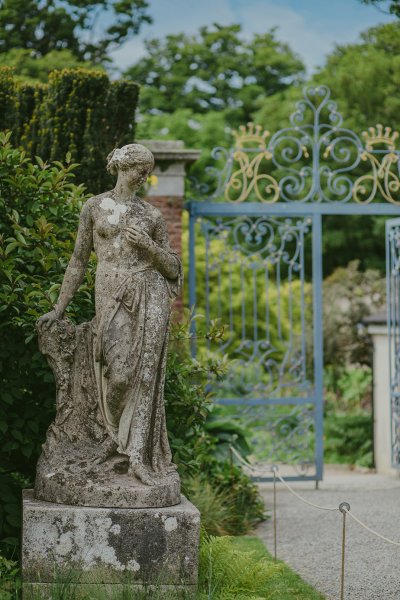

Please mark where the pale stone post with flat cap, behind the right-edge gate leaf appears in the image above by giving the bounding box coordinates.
[364,312,399,477]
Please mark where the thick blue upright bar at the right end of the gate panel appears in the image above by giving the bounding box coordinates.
[312,214,324,481]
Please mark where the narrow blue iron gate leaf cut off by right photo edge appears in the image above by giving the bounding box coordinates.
[386,218,400,469]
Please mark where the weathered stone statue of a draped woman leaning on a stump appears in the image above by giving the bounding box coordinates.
[35,144,182,507]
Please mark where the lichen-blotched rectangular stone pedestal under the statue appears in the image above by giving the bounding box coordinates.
[22,490,200,598]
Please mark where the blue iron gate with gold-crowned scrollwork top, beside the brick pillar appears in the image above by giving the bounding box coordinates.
[188,86,400,480]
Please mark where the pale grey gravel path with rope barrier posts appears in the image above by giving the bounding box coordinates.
[257,468,400,600]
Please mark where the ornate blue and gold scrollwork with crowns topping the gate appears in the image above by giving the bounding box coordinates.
[208,86,400,204]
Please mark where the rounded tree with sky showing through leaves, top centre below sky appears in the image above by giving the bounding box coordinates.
[125,24,304,123]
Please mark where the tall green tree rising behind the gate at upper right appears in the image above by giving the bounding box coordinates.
[253,21,400,274]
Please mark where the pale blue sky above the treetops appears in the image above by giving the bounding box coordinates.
[108,0,395,73]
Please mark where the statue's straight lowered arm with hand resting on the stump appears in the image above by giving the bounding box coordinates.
[38,202,93,325]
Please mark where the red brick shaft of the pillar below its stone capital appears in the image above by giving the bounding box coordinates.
[146,196,183,315]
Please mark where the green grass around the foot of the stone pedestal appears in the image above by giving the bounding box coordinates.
[0,536,324,600]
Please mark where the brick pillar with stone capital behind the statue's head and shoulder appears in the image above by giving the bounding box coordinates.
[138,140,200,314]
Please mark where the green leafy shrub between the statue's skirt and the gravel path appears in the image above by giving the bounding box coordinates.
[165,320,265,535]
